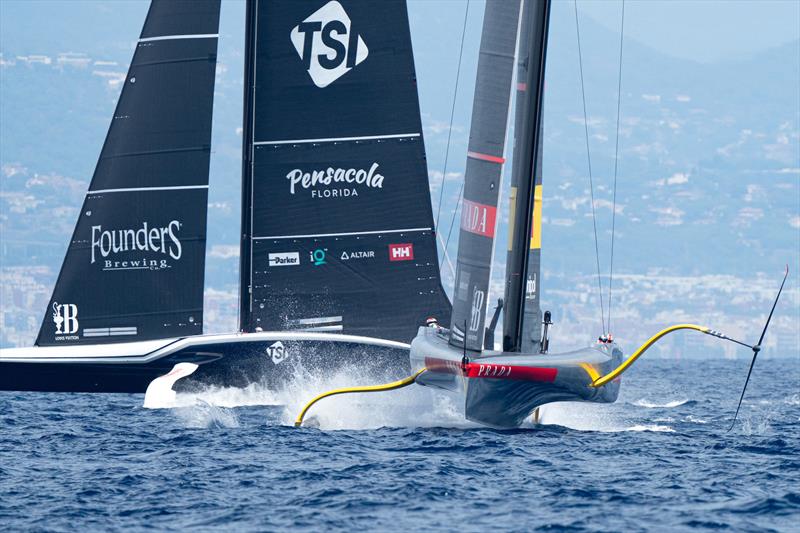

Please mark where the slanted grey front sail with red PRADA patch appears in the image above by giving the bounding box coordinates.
[450,0,520,350]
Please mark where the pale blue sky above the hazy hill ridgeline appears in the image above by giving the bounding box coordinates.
[0,0,800,62]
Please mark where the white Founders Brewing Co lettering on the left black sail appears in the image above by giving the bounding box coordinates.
[91,220,183,270]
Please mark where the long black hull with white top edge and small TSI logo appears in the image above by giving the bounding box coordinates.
[0,336,410,393]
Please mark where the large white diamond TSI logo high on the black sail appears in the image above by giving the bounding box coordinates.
[289,0,369,89]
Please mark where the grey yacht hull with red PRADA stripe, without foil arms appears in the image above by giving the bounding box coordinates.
[410,328,622,428]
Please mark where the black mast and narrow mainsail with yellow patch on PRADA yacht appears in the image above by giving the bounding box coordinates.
[503,0,550,352]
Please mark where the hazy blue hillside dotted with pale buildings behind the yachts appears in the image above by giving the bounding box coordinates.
[0,2,800,354]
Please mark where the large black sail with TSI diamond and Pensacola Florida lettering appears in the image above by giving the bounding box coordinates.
[241,0,450,342]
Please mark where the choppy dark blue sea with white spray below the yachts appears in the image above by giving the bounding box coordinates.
[0,358,800,531]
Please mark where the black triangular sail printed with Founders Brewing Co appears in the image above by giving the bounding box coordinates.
[36,0,220,346]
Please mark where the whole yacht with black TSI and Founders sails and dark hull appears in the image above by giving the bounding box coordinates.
[0,0,450,392]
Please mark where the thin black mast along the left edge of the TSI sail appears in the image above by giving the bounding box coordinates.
[239,0,256,331]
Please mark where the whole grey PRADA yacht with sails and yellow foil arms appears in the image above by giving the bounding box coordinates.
[400,0,789,428]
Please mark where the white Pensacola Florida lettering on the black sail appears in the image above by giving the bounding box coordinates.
[286,163,383,199]
